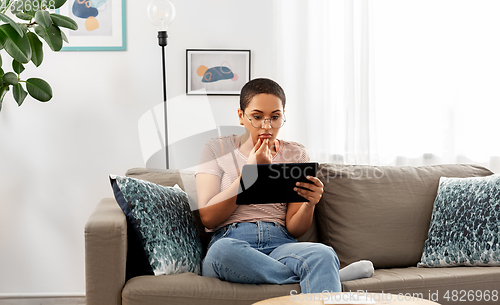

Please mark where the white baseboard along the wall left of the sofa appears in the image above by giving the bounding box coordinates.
[0,293,85,305]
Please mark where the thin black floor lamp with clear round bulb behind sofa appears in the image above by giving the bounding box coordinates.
[147,0,175,169]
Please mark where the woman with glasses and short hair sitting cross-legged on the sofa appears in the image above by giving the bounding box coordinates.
[195,78,372,293]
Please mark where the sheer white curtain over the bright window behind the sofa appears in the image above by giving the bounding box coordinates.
[277,0,500,172]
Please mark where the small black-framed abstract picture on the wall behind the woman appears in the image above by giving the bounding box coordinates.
[186,49,250,95]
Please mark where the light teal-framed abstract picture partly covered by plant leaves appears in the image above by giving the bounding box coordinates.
[56,0,127,51]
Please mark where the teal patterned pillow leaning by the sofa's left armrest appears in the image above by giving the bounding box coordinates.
[110,175,202,275]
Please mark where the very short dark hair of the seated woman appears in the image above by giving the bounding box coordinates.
[240,78,286,111]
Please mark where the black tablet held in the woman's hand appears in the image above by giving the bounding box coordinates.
[236,162,318,205]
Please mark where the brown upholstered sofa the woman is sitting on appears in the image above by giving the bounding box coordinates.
[85,163,500,305]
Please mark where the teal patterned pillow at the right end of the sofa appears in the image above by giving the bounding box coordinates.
[418,175,500,267]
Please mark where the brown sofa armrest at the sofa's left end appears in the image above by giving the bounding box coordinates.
[85,198,127,305]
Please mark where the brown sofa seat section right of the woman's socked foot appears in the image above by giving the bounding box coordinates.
[342,267,500,305]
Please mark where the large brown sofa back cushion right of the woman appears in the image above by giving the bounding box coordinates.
[316,163,492,269]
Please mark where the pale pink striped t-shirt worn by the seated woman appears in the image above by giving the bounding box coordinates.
[195,135,310,232]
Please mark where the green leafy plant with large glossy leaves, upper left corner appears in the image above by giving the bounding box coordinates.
[0,0,78,110]
